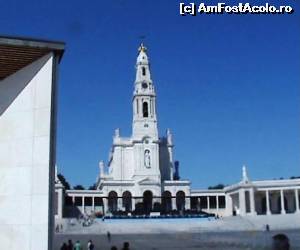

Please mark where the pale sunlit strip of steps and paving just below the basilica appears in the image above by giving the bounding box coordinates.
[57,214,300,235]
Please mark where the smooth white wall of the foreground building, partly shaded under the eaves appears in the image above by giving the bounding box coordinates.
[0,54,53,250]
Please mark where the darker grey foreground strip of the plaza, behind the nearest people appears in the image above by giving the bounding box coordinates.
[54,230,300,250]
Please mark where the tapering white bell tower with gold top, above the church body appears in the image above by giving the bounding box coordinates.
[132,44,158,140]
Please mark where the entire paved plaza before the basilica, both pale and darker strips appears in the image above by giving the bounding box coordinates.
[55,214,300,250]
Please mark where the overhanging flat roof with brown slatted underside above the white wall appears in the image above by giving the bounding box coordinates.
[0,35,65,80]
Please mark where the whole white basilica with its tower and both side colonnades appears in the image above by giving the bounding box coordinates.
[55,44,300,218]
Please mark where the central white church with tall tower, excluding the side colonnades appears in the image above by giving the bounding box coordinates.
[97,45,190,215]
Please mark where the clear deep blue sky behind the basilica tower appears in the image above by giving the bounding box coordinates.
[0,0,300,188]
